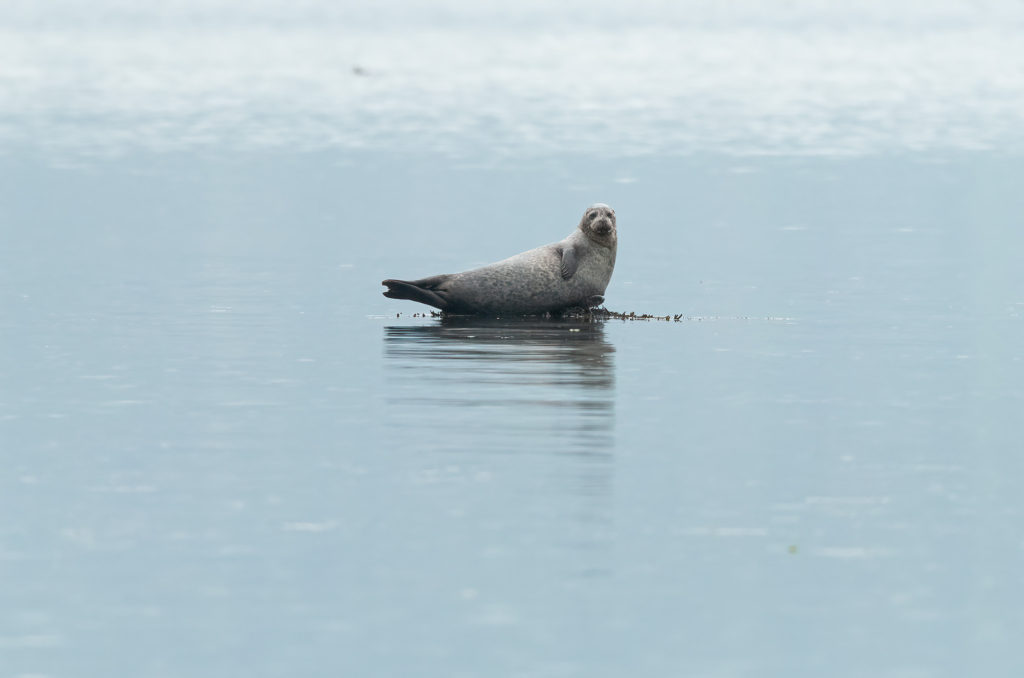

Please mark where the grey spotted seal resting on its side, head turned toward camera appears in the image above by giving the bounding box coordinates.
[381,203,618,314]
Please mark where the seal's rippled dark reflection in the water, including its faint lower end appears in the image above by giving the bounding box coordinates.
[381,315,616,540]
